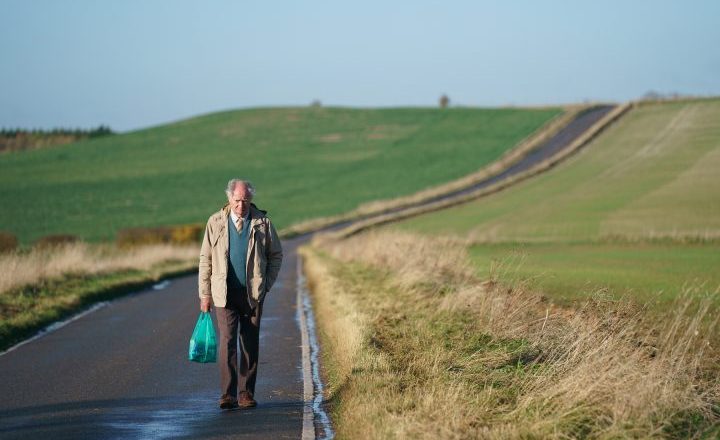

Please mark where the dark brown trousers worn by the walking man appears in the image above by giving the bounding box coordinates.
[215,290,262,397]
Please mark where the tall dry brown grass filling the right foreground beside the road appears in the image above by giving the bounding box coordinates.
[305,232,720,438]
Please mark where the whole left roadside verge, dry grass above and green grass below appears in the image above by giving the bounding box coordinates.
[0,243,197,351]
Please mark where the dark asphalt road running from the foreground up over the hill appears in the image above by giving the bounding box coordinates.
[0,107,610,439]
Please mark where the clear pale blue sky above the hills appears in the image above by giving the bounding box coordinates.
[0,0,720,131]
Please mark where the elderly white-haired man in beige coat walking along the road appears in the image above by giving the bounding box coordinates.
[199,179,283,409]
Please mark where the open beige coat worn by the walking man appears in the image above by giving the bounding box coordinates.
[198,204,282,308]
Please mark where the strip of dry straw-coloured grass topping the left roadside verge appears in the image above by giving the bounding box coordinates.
[0,242,198,293]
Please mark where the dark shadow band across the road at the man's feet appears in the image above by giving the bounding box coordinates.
[0,396,303,439]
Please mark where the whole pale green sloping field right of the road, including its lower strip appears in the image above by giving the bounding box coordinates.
[391,99,720,299]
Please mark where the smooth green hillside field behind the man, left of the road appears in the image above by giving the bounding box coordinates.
[0,108,561,243]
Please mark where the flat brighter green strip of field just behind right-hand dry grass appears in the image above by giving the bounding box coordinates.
[470,243,720,303]
